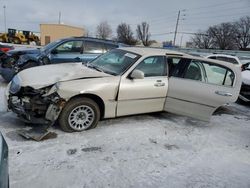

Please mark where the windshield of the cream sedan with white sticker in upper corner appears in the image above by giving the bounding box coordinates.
[87,49,141,75]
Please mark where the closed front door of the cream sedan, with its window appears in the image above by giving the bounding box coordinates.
[117,56,168,116]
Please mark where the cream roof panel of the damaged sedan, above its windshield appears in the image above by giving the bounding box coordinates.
[119,47,188,56]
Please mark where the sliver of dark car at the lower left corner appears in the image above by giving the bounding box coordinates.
[0,132,9,188]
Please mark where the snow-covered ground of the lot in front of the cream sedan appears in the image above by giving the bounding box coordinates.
[0,76,250,188]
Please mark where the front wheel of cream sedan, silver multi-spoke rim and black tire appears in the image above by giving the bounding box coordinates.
[58,97,100,132]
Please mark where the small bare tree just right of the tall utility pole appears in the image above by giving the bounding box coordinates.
[191,31,212,49]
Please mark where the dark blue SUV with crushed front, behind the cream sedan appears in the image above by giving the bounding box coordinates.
[0,37,125,82]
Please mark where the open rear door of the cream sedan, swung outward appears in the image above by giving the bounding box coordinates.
[164,58,241,121]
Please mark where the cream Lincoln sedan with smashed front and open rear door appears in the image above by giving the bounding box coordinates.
[7,47,241,132]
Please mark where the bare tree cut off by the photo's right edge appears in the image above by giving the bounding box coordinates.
[234,16,250,49]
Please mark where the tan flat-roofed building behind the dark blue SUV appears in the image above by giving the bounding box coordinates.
[40,24,86,46]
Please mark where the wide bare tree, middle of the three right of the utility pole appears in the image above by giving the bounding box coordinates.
[208,23,236,50]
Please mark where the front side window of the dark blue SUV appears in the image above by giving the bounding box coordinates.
[56,41,82,53]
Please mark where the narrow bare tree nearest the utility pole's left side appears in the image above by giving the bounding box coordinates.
[136,22,152,46]
